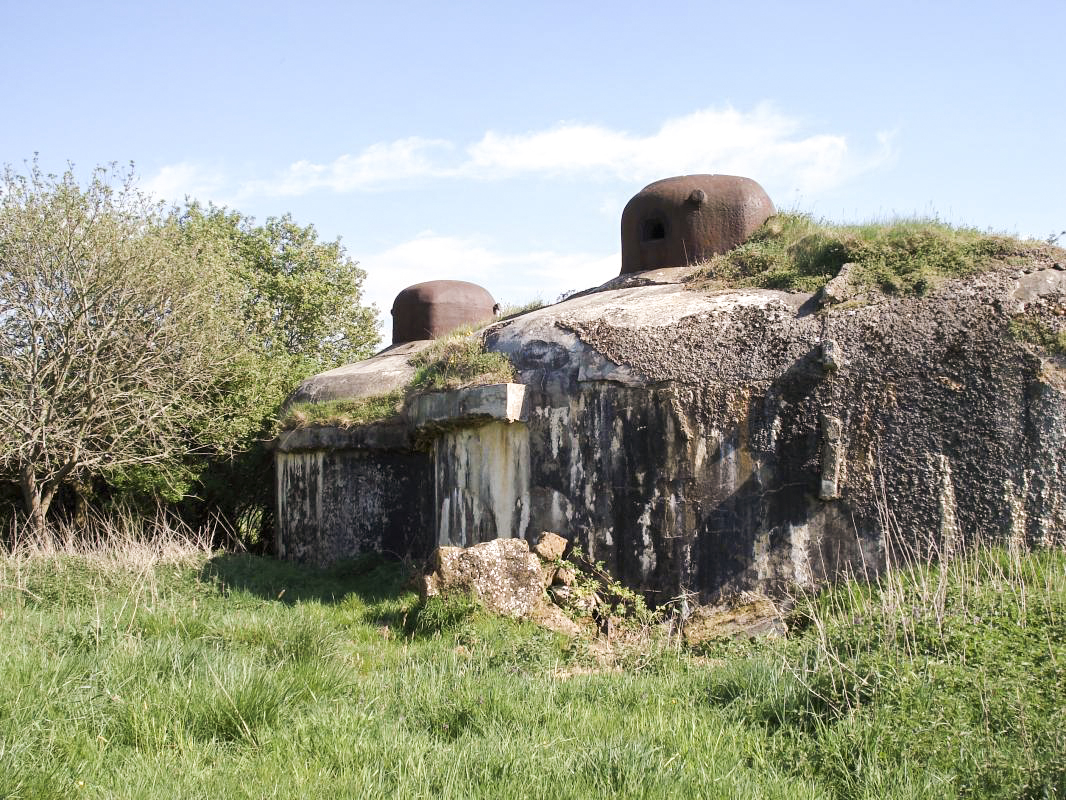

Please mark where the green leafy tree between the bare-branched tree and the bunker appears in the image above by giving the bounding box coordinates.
[162,202,379,538]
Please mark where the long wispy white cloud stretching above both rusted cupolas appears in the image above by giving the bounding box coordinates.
[141,105,892,198]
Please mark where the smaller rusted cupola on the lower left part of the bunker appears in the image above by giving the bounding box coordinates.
[392,281,496,345]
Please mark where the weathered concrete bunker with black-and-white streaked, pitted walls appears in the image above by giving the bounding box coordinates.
[276,176,1066,602]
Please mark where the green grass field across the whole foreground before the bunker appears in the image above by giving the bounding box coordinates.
[0,526,1066,800]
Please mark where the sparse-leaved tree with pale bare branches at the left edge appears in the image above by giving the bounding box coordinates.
[0,162,241,527]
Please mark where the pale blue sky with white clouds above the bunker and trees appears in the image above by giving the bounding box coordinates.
[0,0,1066,330]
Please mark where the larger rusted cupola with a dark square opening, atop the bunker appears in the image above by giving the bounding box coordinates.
[621,175,776,275]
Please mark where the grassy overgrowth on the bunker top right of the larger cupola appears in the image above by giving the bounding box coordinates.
[691,213,1066,294]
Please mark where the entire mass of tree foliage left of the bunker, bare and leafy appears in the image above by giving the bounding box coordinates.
[0,162,377,533]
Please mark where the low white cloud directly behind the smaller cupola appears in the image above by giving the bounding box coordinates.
[359,231,621,324]
